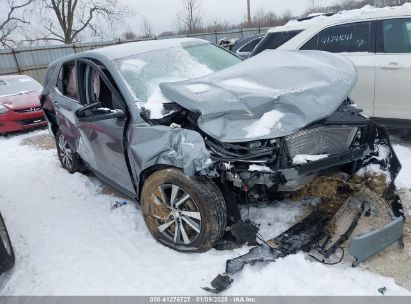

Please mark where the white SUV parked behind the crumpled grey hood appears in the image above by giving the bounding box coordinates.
[253,4,411,127]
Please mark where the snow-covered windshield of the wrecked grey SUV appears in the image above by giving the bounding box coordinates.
[116,43,241,102]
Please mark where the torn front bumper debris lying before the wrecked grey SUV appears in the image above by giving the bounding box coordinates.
[203,126,405,293]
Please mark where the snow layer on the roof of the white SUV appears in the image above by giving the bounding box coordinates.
[268,3,411,33]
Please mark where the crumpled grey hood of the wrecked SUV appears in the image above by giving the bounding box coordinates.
[160,50,357,142]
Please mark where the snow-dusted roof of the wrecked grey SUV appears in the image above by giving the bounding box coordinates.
[85,38,209,60]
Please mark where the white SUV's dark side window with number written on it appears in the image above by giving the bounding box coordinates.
[301,22,371,53]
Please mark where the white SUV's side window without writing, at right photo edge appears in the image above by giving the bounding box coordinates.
[377,18,411,53]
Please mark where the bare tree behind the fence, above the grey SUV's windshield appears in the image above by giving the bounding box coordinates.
[177,0,204,34]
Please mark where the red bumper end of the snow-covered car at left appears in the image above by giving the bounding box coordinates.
[0,110,47,133]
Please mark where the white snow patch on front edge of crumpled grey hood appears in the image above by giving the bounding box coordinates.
[244,110,284,138]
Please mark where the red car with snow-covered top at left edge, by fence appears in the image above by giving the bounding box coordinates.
[0,75,47,134]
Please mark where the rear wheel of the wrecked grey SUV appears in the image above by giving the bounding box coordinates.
[56,129,83,174]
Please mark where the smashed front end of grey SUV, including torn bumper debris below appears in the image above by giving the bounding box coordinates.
[205,100,405,293]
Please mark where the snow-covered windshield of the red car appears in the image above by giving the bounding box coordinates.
[0,76,42,97]
